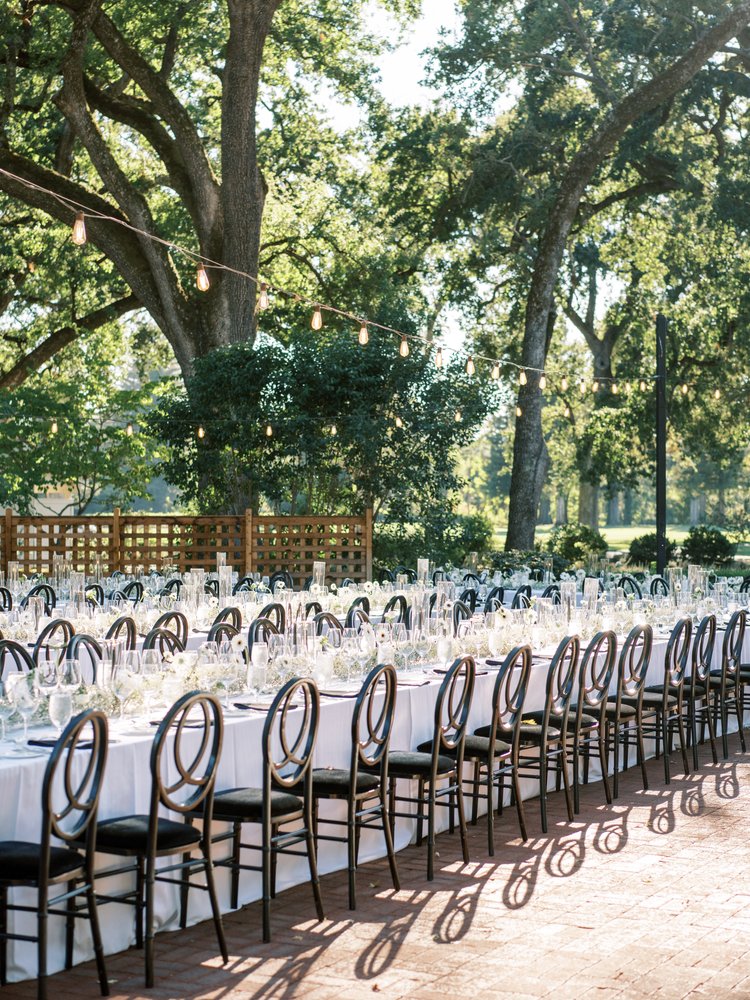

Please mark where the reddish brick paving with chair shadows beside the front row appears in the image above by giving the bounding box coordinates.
[5,737,750,1000]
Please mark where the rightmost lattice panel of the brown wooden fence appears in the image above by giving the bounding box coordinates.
[251,516,371,586]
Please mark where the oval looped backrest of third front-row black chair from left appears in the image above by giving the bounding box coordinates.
[263,677,320,796]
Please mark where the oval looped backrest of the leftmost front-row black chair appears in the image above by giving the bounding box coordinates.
[41,709,108,864]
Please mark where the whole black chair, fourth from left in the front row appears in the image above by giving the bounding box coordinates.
[313,664,401,910]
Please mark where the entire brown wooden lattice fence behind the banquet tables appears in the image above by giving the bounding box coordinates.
[0,508,372,584]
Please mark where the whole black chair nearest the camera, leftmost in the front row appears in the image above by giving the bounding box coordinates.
[0,711,109,1000]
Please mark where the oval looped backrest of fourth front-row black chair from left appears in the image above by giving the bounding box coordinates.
[351,663,398,772]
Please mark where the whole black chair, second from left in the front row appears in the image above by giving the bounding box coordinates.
[89,691,229,987]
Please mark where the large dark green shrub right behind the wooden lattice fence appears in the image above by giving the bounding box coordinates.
[151,328,500,523]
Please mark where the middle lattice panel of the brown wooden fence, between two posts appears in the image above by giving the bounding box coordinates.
[120,515,245,573]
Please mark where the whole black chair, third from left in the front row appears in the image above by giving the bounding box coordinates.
[207,677,325,941]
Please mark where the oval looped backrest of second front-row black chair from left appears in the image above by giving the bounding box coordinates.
[149,691,224,824]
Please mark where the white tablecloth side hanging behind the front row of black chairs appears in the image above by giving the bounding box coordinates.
[0,632,750,982]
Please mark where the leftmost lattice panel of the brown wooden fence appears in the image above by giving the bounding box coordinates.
[9,517,115,575]
